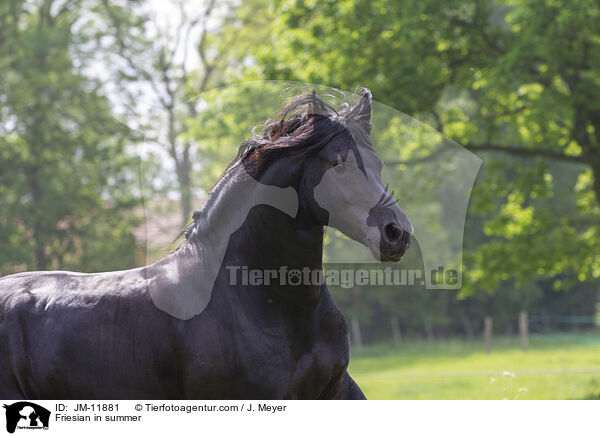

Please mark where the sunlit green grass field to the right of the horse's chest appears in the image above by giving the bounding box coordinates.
[350,333,600,400]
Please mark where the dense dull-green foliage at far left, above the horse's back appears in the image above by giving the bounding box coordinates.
[0,1,137,273]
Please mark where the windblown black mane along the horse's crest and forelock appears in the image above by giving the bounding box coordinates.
[184,88,371,240]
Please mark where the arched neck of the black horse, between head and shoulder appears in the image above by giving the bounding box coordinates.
[144,164,323,320]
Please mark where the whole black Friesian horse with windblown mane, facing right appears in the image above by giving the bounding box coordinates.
[0,90,413,399]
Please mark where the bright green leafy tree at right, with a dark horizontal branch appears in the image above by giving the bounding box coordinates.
[255,0,600,293]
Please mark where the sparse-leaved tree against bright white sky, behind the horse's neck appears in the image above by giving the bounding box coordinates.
[100,0,269,225]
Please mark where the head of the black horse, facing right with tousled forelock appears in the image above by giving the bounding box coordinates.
[234,89,414,262]
